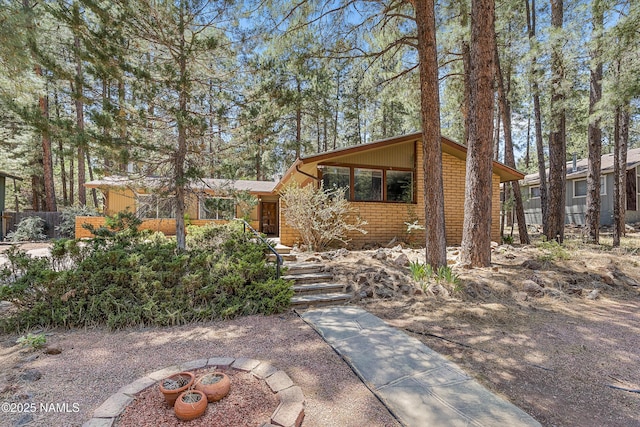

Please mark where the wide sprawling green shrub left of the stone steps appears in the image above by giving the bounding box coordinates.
[0,222,293,331]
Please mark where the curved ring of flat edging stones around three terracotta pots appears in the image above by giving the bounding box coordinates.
[82,357,305,427]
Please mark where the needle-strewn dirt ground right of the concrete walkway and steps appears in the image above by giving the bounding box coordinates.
[0,233,640,427]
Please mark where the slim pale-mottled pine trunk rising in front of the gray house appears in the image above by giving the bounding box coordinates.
[583,0,604,244]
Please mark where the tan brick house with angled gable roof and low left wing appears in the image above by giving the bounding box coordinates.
[76,133,524,247]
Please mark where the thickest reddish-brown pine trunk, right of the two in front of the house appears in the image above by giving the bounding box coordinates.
[460,0,495,267]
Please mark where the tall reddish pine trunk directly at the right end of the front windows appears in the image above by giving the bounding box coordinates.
[413,0,447,267]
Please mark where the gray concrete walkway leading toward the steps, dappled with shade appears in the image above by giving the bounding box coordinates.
[301,307,540,427]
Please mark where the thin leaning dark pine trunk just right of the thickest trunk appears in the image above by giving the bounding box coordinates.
[493,32,530,245]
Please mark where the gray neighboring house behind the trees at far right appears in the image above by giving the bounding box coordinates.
[521,148,640,225]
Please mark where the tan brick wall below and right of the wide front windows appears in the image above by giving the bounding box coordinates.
[280,142,500,248]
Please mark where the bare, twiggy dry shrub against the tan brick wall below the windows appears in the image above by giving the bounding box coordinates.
[280,185,367,251]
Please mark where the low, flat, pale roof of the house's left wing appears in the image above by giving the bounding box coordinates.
[85,176,277,194]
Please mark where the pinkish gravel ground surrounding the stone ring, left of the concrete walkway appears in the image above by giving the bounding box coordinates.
[0,313,399,427]
